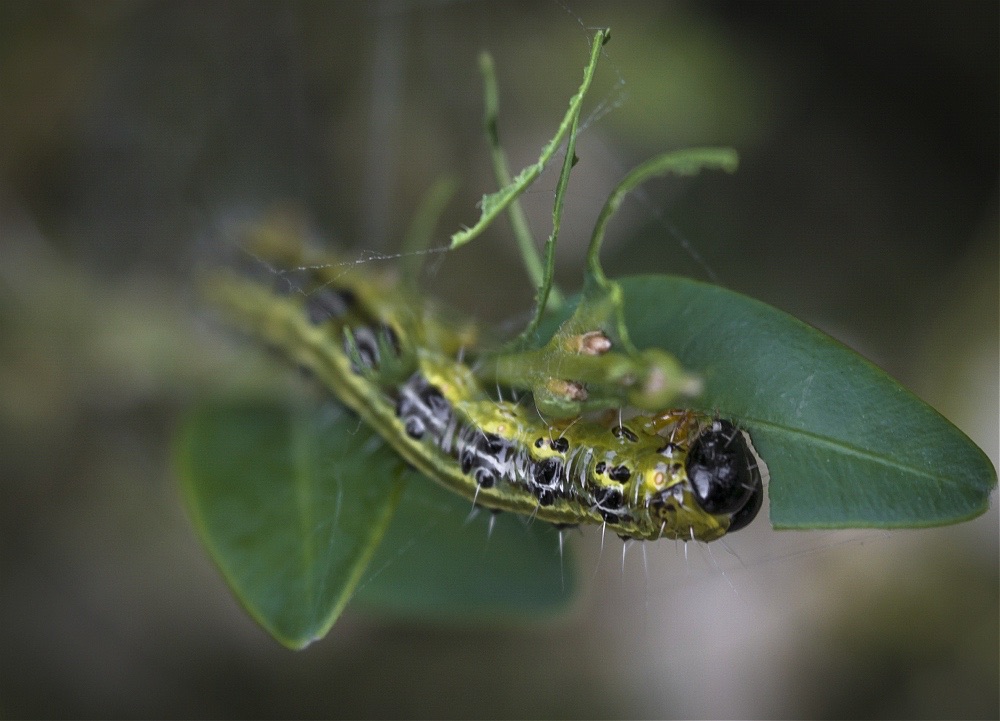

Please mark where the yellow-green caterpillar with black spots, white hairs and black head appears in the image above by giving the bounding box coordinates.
[204,222,763,541]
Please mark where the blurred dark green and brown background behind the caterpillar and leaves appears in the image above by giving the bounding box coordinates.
[0,0,1000,718]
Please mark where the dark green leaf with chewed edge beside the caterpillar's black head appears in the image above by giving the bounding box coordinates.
[592,276,997,528]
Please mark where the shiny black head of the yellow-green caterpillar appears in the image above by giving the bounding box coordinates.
[686,419,764,533]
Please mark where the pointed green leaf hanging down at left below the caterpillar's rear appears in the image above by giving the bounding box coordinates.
[178,403,404,648]
